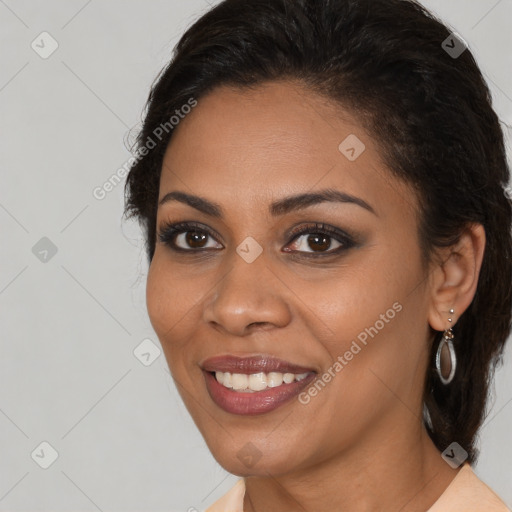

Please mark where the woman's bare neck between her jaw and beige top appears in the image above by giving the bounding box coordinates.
[244,418,459,512]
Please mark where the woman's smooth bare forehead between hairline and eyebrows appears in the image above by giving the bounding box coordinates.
[159,82,416,218]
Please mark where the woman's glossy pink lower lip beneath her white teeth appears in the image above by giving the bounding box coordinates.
[203,372,316,415]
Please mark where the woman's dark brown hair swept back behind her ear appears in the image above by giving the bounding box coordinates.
[125,0,512,462]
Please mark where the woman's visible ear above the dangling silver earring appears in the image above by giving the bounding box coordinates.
[429,224,485,331]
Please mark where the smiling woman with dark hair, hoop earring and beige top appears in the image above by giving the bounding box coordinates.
[126,0,512,512]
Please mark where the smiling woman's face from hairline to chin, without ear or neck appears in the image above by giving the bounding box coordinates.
[147,82,436,475]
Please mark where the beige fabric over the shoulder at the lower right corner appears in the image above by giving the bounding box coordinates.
[427,463,511,512]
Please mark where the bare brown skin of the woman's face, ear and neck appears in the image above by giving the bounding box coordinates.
[147,81,485,512]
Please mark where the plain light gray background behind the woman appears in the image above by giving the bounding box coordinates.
[0,0,512,512]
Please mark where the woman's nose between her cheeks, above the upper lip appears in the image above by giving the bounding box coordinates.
[203,252,291,336]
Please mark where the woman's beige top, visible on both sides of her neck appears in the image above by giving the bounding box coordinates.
[206,463,511,512]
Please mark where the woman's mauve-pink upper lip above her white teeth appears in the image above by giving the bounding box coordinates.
[201,355,315,375]
